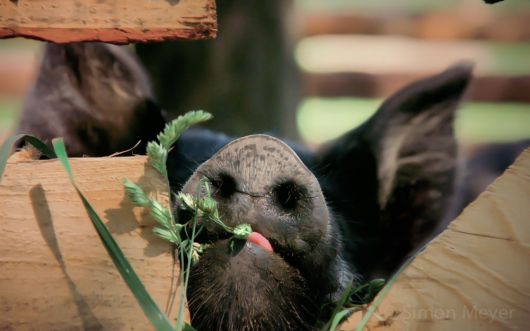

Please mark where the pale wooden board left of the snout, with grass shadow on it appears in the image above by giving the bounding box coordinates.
[0,153,185,330]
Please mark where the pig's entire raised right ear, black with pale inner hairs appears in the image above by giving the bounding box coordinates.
[314,64,471,274]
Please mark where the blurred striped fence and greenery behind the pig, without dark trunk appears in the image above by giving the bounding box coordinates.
[0,0,530,146]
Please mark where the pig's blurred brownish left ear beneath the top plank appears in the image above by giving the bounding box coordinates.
[18,43,164,156]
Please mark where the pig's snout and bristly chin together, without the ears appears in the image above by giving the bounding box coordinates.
[179,135,349,330]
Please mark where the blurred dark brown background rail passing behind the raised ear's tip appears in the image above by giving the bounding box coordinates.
[0,52,530,103]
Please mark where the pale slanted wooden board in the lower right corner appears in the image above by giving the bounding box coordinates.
[342,149,530,331]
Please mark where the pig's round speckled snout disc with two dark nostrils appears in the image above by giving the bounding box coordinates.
[181,135,329,251]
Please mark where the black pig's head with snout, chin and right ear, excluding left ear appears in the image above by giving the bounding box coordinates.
[169,64,471,330]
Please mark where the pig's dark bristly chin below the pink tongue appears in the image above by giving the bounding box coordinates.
[188,240,318,331]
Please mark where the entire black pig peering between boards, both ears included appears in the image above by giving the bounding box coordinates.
[20,44,471,330]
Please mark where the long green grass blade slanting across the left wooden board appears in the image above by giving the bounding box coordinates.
[52,139,175,331]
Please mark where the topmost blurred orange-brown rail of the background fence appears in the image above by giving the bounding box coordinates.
[300,10,530,42]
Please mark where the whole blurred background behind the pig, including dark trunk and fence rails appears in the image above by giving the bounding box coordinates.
[0,0,530,162]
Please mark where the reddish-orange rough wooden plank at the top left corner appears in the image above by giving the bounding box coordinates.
[0,0,217,44]
